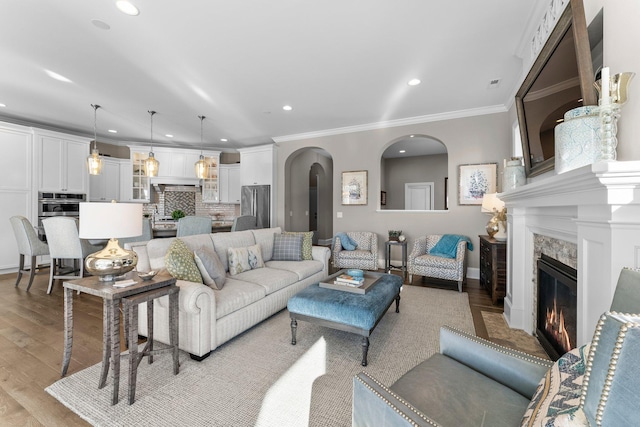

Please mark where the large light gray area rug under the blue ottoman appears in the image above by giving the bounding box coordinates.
[46,285,474,427]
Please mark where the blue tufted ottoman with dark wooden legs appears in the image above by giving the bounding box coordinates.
[287,272,402,366]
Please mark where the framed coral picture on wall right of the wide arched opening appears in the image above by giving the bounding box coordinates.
[458,163,498,205]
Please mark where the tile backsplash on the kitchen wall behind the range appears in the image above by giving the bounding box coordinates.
[144,185,240,220]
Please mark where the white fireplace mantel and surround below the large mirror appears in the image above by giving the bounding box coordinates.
[500,161,640,345]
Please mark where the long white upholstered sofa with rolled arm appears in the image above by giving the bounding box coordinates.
[127,227,331,360]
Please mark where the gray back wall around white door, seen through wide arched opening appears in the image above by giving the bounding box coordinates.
[382,154,451,209]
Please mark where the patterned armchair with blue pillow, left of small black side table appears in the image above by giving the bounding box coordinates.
[333,231,378,270]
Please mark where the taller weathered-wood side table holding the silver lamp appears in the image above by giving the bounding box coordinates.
[61,272,176,405]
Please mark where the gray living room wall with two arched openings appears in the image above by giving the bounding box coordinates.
[275,112,512,268]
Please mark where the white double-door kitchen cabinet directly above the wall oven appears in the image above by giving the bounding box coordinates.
[36,132,89,193]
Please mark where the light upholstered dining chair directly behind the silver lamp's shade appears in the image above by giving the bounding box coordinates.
[42,217,104,294]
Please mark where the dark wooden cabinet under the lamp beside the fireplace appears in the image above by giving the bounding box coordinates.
[478,236,507,305]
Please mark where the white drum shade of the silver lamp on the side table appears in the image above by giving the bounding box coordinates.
[79,202,142,239]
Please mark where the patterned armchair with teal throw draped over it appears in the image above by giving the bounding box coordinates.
[407,234,467,292]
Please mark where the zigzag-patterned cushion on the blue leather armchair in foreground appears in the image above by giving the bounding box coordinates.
[522,345,589,427]
